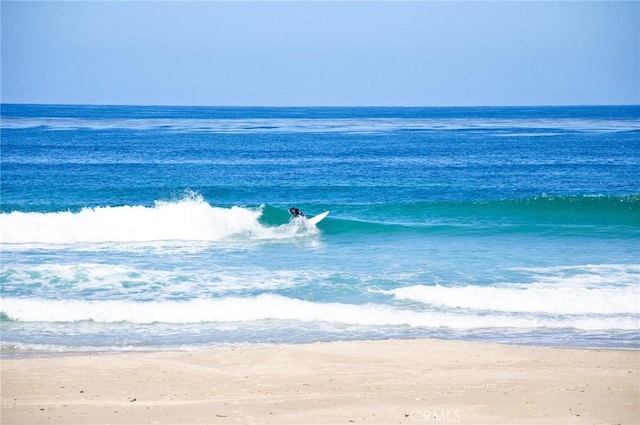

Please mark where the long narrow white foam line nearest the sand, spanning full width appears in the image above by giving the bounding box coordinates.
[1,294,638,330]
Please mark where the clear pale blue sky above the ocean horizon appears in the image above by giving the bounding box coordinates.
[0,0,640,106]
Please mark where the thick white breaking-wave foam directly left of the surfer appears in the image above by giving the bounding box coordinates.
[0,196,314,245]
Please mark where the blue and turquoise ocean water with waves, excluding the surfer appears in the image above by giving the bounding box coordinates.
[0,104,640,355]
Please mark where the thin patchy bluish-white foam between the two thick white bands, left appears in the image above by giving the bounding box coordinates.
[0,263,324,302]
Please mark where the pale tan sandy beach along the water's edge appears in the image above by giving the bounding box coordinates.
[1,340,640,425]
